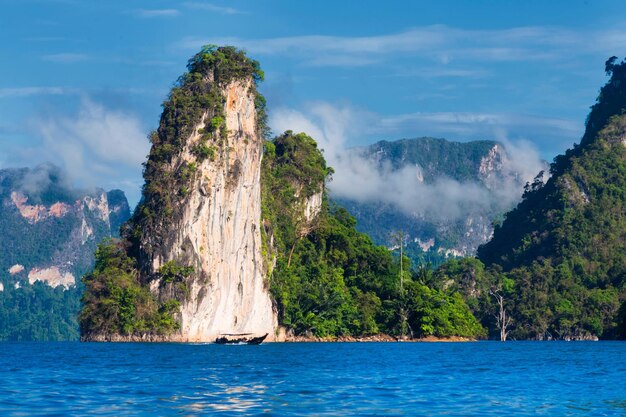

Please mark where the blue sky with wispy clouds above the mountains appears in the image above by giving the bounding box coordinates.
[0,0,626,203]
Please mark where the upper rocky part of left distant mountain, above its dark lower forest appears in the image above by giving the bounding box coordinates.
[0,164,130,287]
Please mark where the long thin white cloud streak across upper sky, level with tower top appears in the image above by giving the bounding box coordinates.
[177,25,626,67]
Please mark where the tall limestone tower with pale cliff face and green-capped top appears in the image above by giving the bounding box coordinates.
[83,47,278,341]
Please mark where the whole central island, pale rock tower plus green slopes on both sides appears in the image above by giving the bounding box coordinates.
[81,47,486,340]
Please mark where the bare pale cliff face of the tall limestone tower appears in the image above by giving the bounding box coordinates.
[150,80,278,342]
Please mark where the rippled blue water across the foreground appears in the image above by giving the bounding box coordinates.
[0,342,626,416]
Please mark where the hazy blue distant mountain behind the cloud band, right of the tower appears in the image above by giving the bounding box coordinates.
[331,137,540,264]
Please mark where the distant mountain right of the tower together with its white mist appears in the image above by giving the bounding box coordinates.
[272,103,547,263]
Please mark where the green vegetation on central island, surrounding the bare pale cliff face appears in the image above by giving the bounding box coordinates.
[80,47,484,339]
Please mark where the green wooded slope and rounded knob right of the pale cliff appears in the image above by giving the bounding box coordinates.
[261,131,484,337]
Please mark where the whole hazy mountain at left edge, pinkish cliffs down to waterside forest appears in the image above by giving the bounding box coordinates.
[0,164,130,340]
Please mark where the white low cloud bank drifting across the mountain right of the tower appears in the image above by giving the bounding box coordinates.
[270,103,544,221]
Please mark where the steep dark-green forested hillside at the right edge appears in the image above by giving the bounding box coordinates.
[437,59,626,339]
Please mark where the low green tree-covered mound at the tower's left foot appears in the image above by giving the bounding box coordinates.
[80,241,179,336]
